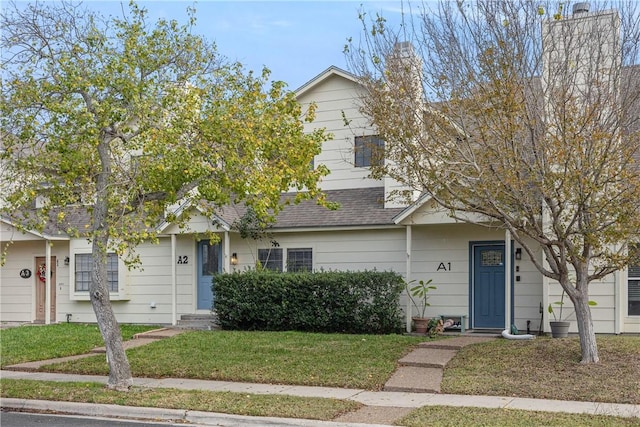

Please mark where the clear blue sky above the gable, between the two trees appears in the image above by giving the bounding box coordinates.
[71,0,401,90]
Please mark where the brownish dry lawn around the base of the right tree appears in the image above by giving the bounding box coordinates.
[441,335,640,404]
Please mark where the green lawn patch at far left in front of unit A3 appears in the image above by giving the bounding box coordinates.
[0,323,158,367]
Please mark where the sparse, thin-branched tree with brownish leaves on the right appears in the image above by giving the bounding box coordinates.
[345,0,640,363]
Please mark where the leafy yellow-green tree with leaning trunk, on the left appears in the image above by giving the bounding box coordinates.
[0,2,328,390]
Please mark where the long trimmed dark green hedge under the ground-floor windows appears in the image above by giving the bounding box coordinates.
[213,270,404,334]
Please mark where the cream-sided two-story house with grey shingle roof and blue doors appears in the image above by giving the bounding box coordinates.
[0,5,640,333]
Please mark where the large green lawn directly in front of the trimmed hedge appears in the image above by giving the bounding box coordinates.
[37,331,425,390]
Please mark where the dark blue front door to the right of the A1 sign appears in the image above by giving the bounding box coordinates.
[472,244,505,328]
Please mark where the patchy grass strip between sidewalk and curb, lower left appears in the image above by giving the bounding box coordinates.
[0,379,362,420]
